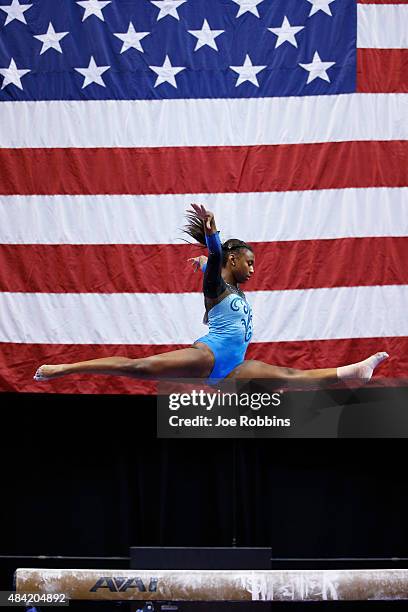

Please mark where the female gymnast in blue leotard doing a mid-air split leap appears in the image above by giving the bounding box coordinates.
[34,204,388,388]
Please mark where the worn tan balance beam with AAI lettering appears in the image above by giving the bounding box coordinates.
[15,568,408,601]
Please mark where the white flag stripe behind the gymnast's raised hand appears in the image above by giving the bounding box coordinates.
[0,187,408,244]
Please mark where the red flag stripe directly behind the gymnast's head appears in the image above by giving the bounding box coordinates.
[0,237,408,293]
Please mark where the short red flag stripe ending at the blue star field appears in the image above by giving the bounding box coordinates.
[357,49,408,93]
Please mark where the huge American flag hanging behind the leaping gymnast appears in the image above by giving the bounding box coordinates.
[0,0,408,393]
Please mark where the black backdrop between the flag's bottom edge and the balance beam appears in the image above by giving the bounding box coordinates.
[0,394,408,608]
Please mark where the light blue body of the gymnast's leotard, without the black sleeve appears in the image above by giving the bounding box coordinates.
[195,234,253,379]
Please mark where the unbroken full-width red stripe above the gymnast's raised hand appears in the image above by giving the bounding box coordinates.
[0,140,408,195]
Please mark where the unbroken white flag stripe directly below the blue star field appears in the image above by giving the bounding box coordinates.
[0,94,408,147]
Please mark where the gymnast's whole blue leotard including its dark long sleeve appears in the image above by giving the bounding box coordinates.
[195,232,252,379]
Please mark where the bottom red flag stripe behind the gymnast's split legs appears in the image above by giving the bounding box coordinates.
[0,337,408,394]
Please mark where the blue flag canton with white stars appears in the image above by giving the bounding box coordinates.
[0,0,357,100]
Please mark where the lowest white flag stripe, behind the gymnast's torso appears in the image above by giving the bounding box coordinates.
[0,285,408,349]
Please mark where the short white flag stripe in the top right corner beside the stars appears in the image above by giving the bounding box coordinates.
[357,4,408,49]
